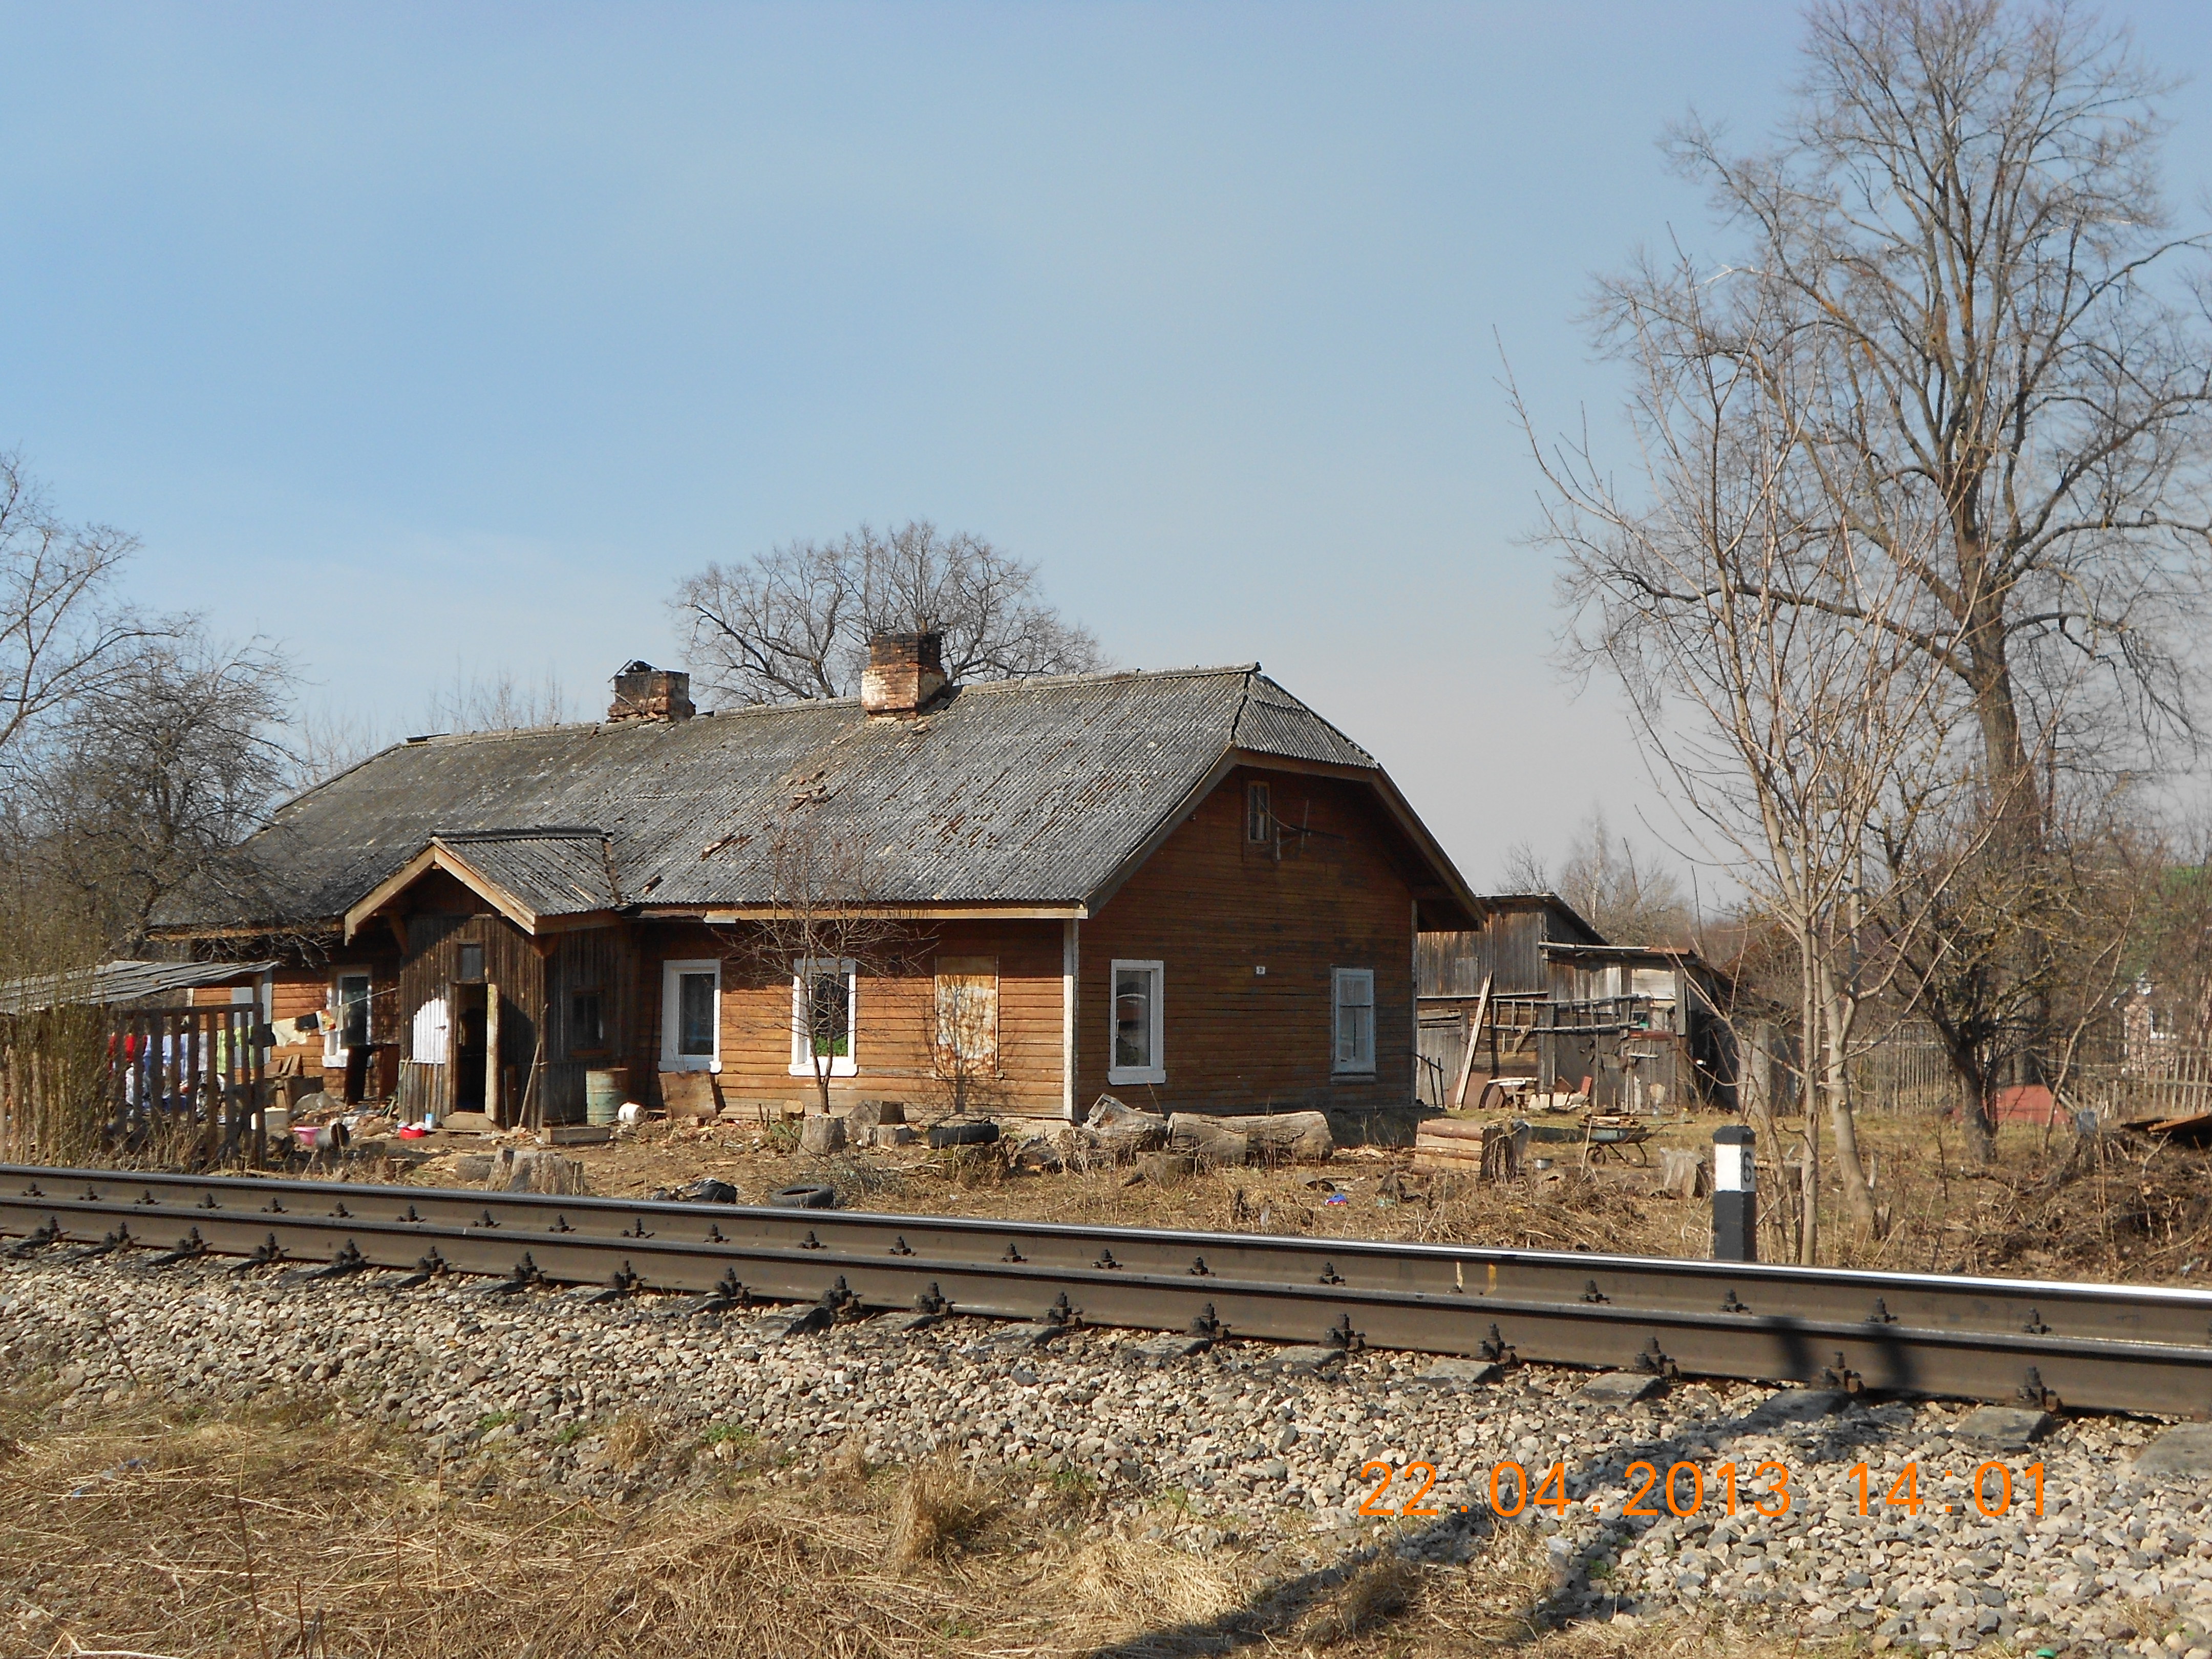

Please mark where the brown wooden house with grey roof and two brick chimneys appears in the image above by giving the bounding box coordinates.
[164,635,1484,1121]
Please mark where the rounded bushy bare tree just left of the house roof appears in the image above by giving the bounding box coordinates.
[22,633,292,953]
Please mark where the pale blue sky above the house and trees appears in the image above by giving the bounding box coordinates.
[0,0,2212,891]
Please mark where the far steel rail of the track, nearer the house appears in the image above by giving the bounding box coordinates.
[0,1166,2212,1349]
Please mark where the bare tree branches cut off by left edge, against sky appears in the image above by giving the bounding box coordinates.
[0,454,173,759]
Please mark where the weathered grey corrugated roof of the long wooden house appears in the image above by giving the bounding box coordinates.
[181,664,1407,929]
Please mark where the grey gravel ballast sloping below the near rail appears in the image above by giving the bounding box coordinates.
[0,1257,2212,1659]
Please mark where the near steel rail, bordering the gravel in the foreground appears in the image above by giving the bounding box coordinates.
[0,1181,2212,1416]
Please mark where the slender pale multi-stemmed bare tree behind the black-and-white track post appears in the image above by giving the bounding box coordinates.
[1515,243,1969,1261]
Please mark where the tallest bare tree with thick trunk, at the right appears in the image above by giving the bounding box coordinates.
[1570,0,2212,1157]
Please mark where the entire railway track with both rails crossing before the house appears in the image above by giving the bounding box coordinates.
[0,1166,2212,1418]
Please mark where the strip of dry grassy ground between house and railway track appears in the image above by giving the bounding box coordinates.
[352,1113,2212,1285]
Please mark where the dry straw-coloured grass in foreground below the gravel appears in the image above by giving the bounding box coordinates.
[0,1378,1845,1659]
